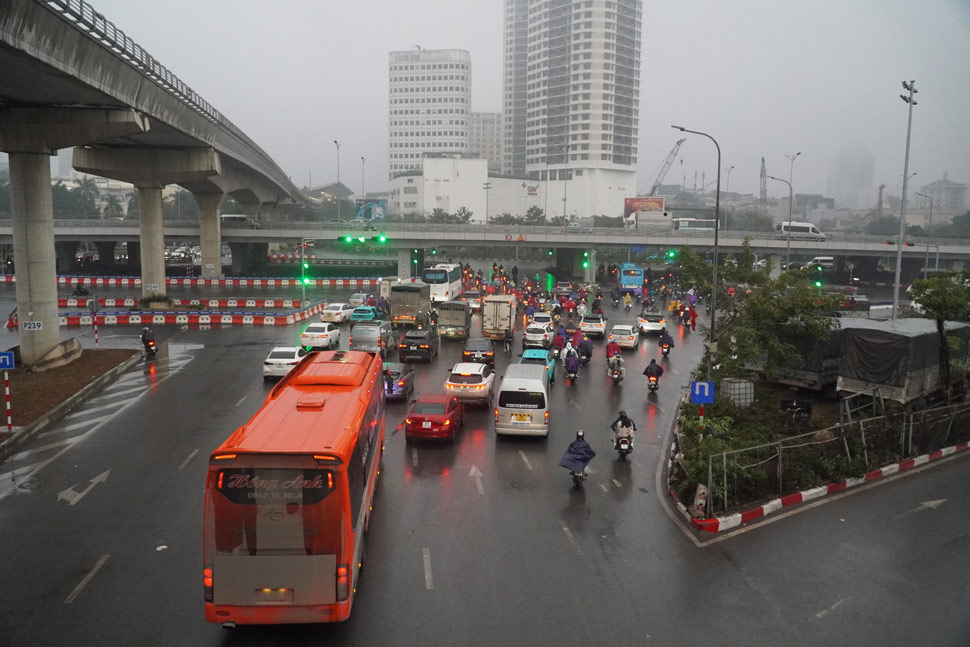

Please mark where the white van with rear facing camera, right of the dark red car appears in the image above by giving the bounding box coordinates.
[495,364,549,436]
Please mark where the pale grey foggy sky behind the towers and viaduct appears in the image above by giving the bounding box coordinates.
[41,0,970,206]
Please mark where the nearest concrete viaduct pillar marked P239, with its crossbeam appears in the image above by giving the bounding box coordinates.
[0,107,148,371]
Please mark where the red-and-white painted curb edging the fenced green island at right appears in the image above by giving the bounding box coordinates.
[669,442,970,533]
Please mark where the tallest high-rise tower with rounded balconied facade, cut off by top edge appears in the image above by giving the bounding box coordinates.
[503,0,642,216]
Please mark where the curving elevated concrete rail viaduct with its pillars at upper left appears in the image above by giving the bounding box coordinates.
[0,0,305,369]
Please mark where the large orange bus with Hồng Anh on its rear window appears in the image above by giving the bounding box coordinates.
[202,351,384,627]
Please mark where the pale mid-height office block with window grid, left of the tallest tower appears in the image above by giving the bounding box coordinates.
[387,48,472,178]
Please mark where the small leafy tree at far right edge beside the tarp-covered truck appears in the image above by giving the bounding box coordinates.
[909,272,970,404]
